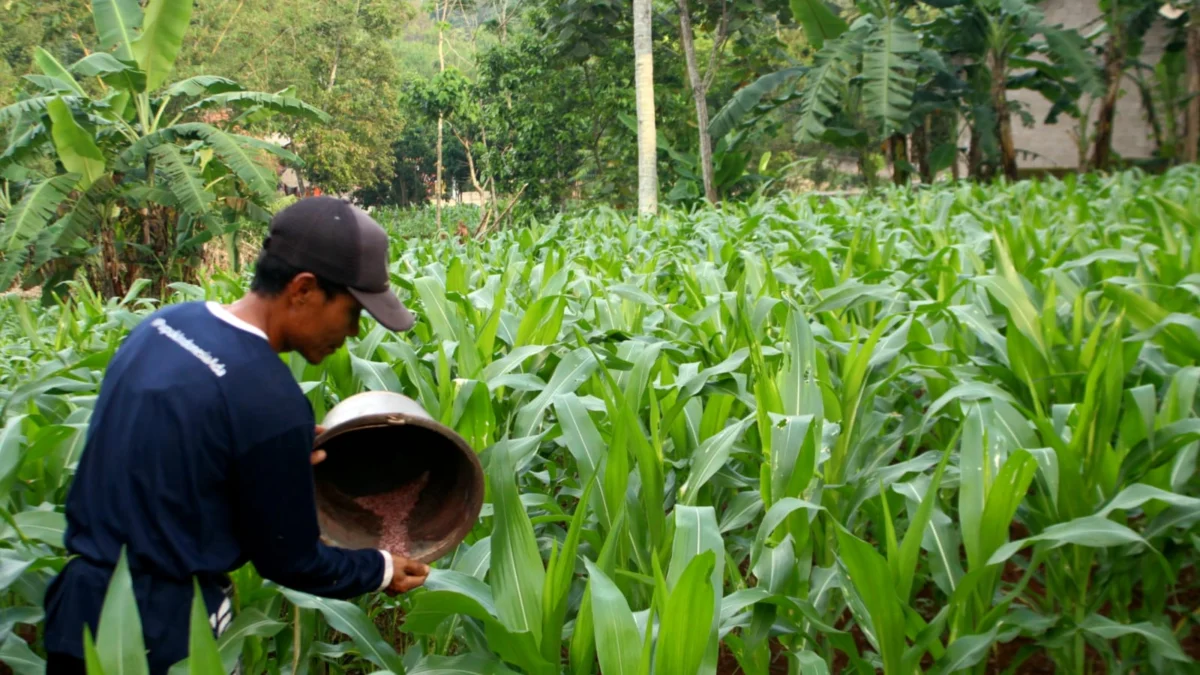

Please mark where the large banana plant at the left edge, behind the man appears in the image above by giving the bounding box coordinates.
[0,0,329,294]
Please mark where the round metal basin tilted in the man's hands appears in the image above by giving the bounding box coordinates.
[313,392,484,563]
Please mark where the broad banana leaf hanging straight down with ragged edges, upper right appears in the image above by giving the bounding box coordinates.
[863,18,920,136]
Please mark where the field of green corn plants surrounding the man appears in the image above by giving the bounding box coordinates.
[0,167,1200,675]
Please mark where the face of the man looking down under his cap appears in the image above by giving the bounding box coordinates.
[284,273,362,364]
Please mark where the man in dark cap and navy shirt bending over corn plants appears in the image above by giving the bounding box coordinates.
[44,197,428,675]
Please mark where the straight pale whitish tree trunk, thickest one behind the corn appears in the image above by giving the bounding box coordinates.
[634,0,659,214]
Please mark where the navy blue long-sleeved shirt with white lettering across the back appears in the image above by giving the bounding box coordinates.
[44,303,386,673]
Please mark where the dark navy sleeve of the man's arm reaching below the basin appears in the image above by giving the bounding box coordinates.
[233,426,391,599]
